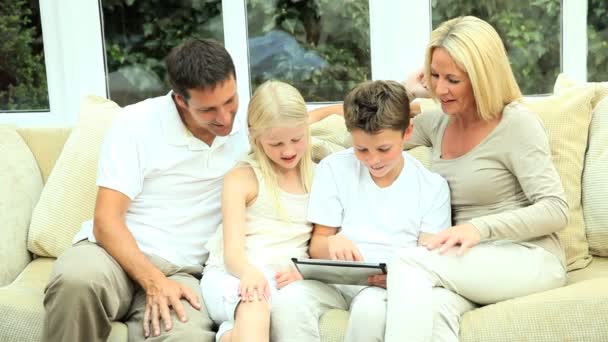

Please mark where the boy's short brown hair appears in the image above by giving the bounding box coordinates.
[344,81,410,134]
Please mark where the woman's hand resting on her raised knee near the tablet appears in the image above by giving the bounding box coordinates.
[423,223,481,255]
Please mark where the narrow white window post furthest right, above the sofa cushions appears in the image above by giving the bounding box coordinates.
[562,0,587,82]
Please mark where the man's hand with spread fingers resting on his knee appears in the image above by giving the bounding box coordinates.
[143,276,201,338]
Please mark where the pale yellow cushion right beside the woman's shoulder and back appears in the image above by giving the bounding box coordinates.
[523,85,596,270]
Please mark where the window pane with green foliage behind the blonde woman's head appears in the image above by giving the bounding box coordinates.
[432,0,561,94]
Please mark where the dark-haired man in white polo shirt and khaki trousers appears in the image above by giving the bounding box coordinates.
[43,39,249,341]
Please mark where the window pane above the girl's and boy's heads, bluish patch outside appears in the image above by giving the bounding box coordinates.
[247,0,371,102]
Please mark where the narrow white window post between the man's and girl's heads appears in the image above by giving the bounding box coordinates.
[222,0,251,111]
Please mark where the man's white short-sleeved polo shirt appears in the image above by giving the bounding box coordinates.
[74,93,249,266]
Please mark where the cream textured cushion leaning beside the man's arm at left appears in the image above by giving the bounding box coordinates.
[28,97,120,257]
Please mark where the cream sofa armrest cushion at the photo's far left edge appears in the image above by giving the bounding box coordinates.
[0,127,42,286]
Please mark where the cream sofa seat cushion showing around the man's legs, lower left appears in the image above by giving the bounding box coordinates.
[0,258,127,342]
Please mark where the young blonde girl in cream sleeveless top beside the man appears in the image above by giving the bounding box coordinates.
[201,81,313,342]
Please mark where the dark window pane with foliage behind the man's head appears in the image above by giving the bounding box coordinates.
[102,0,224,106]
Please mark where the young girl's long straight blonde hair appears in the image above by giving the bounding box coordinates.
[247,80,313,218]
